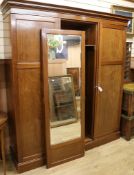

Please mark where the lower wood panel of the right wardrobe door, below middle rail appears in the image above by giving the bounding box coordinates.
[94,65,122,137]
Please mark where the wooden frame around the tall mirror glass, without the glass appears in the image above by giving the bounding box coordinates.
[41,29,85,168]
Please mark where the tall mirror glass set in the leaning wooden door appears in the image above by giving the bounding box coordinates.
[47,34,81,145]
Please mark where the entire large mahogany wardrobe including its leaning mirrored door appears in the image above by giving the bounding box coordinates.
[1,0,128,173]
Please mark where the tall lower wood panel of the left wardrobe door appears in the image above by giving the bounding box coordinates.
[18,69,44,157]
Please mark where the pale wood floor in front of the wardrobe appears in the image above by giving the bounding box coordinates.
[0,138,134,175]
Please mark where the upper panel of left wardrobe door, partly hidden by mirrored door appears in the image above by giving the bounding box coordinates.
[17,19,57,62]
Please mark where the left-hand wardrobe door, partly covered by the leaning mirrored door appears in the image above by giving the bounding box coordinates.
[13,15,59,172]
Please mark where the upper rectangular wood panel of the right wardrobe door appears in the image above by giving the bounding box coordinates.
[101,27,124,62]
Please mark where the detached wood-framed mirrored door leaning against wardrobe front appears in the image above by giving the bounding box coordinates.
[42,29,85,167]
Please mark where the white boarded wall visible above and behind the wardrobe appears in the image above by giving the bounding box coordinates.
[0,0,134,59]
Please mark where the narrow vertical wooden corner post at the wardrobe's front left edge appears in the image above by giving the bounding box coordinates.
[10,14,23,162]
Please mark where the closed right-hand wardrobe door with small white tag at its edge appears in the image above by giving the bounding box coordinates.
[94,24,125,138]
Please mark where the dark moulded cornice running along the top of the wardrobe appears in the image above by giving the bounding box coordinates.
[1,0,128,22]
